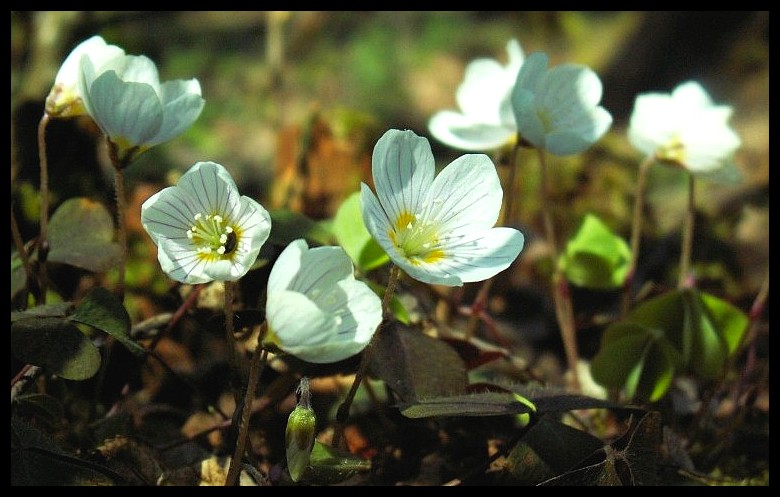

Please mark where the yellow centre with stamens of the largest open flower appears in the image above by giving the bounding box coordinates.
[388,211,445,265]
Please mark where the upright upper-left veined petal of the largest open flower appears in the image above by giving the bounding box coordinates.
[372,129,435,225]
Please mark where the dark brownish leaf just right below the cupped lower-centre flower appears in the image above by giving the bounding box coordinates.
[369,322,468,402]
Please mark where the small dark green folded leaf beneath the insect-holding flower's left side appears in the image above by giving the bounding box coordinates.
[70,286,146,357]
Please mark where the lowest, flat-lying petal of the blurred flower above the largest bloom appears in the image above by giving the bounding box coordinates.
[428,110,515,151]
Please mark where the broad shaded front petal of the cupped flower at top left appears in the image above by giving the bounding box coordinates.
[88,71,163,146]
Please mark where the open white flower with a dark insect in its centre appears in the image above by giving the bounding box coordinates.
[141,162,271,284]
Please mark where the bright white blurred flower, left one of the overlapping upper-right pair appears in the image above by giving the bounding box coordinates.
[428,40,524,150]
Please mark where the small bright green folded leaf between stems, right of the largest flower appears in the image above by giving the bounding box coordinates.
[559,214,631,290]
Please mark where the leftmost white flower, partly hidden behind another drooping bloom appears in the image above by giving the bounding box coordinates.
[46,36,125,117]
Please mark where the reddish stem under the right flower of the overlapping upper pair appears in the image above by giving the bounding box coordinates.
[537,149,580,391]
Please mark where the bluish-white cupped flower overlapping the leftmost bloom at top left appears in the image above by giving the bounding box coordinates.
[79,55,205,162]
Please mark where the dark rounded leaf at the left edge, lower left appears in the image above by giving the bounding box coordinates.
[11,317,100,380]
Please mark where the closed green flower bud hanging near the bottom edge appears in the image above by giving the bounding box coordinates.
[285,377,317,482]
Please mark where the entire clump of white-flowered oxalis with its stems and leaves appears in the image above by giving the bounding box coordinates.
[11,21,768,485]
